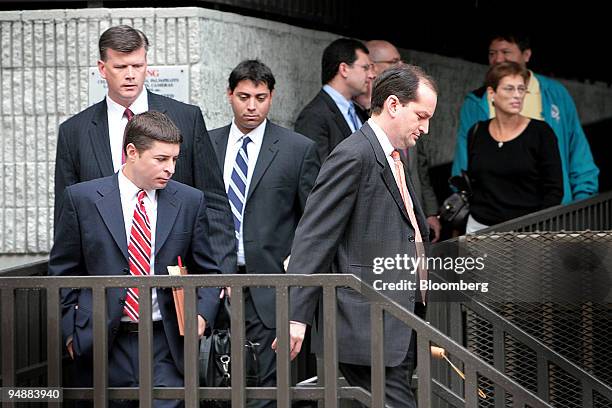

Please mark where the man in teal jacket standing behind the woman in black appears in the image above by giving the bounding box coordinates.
[452,33,599,204]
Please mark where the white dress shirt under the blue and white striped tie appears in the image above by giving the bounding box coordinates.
[223,119,268,265]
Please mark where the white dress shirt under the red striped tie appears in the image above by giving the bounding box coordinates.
[119,169,161,322]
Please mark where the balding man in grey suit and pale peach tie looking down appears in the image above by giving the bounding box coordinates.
[278,65,437,407]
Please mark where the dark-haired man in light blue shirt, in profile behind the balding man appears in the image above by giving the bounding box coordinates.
[295,38,372,161]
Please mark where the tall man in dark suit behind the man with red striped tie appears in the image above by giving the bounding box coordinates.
[55,25,236,273]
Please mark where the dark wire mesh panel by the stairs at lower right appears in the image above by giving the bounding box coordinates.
[461,231,612,408]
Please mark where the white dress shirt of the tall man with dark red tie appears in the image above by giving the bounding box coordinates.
[106,88,149,173]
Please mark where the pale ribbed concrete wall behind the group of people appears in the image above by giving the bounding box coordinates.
[0,8,612,253]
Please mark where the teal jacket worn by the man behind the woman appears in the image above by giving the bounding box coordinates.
[452,74,599,204]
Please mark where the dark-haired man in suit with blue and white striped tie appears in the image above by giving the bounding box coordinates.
[210,60,319,407]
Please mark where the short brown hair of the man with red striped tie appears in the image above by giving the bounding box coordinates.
[123,111,183,153]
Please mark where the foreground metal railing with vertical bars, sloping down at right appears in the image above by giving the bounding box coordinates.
[0,274,550,408]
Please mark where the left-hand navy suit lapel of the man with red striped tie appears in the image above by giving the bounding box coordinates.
[96,174,128,260]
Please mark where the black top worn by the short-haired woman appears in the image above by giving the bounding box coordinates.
[468,119,563,225]
